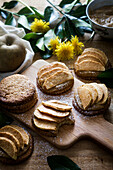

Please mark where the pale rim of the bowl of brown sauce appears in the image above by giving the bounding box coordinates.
[86,0,113,30]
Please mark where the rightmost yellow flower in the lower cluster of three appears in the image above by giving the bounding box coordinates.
[71,36,84,56]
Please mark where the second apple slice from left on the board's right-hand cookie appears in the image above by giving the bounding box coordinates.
[84,84,98,105]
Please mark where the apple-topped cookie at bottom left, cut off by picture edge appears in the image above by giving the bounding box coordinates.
[0,125,33,164]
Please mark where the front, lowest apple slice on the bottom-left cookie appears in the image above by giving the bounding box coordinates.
[0,137,17,160]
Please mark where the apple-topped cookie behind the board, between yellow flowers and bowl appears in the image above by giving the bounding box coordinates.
[74,48,108,79]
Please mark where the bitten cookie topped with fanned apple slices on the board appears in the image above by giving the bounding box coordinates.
[33,100,74,136]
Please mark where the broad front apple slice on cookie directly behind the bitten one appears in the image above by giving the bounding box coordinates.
[43,71,74,90]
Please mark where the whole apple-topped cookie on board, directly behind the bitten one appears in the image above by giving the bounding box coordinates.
[37,62,74,94]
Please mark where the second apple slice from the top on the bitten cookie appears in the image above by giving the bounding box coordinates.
[37,104,70,117]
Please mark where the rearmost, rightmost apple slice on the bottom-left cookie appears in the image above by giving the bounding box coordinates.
[10,125,29,145]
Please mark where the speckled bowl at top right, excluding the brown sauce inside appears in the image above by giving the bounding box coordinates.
[86,0,113,39]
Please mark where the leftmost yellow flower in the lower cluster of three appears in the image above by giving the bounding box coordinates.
[48,36,59,55]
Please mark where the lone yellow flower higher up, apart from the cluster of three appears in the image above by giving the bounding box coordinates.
[31,18,50,33]
